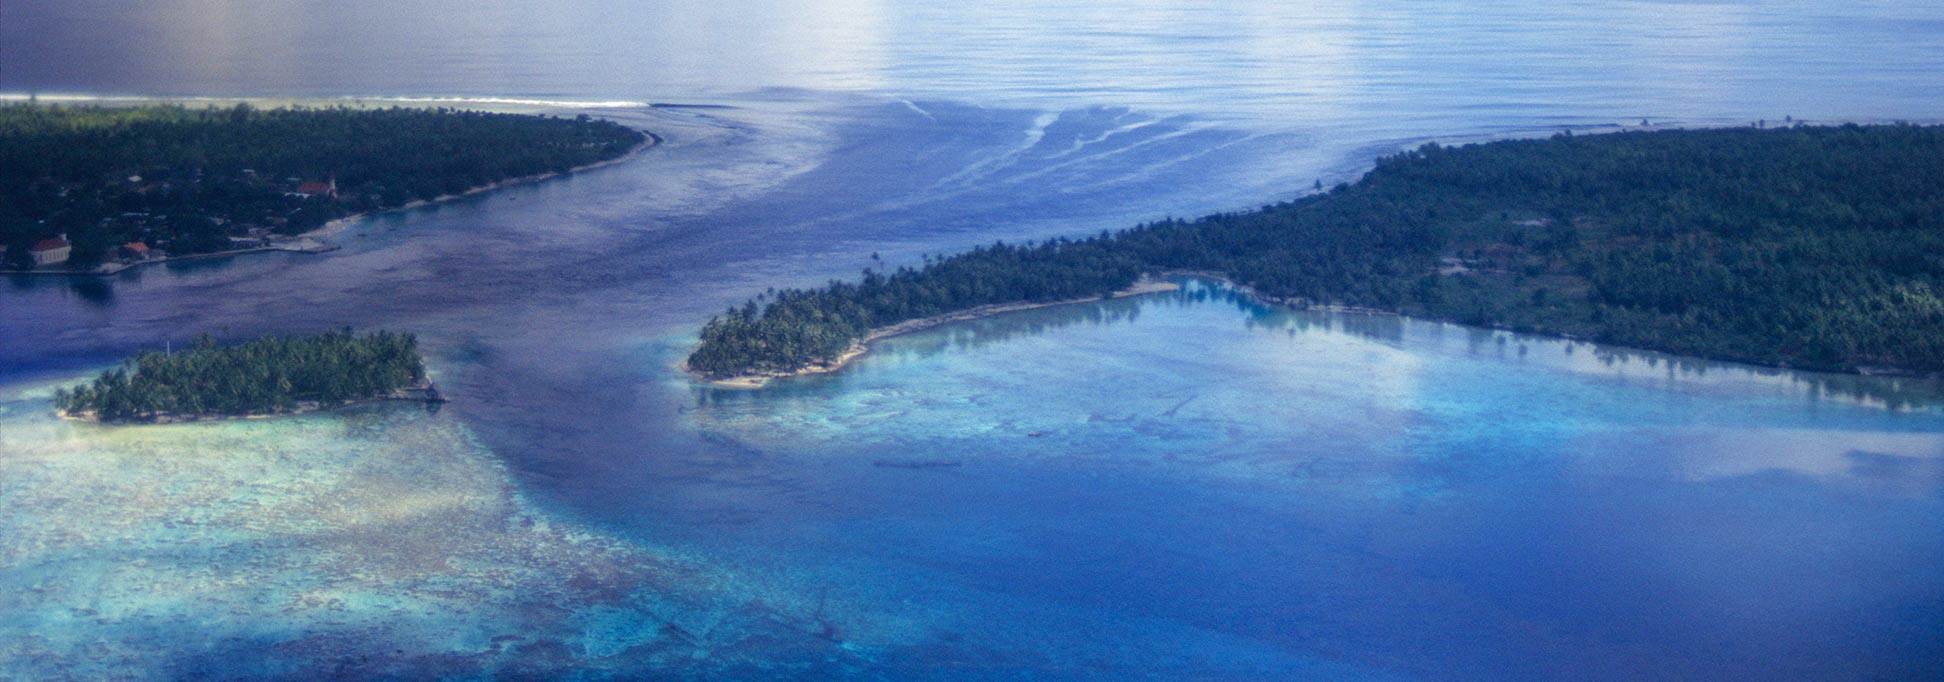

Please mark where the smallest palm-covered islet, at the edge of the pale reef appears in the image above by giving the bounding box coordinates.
[54,328,426,422]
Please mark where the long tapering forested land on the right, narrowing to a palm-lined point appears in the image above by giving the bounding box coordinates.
[688,124,1944,377]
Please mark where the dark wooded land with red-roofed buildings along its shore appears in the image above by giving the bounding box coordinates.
[0,105,645,268]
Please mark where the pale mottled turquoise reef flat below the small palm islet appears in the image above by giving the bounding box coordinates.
[0,387,917,678]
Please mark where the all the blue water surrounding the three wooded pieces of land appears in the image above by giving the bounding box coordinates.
[0,2,1944,680]
